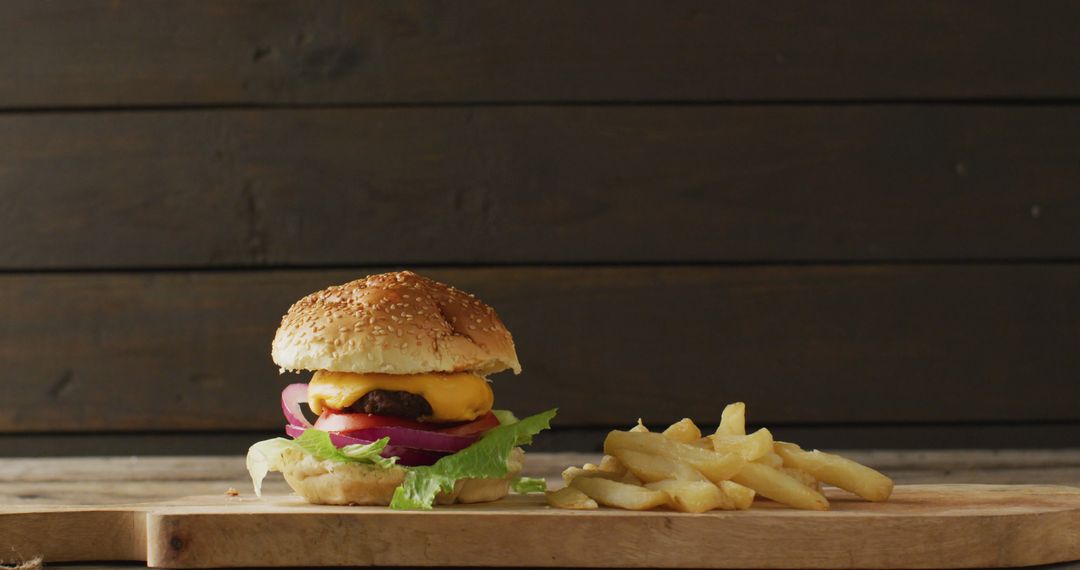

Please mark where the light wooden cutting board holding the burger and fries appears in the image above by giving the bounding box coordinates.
[0,485,1080,568]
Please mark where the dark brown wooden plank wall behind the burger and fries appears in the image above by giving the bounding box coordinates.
[0,0,1080,454]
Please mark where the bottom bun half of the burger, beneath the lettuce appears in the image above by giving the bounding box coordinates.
[281,448,525,506]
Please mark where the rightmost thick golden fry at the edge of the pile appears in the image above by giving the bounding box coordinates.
[773,442,892,501]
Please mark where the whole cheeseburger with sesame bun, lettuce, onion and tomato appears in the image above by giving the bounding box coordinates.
[247,271,555,508]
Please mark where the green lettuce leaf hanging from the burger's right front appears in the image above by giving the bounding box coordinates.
[390,409,557,511]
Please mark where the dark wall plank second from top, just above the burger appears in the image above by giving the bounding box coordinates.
[0,106,1080,269]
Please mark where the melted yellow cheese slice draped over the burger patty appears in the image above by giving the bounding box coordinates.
[308,370,495,422]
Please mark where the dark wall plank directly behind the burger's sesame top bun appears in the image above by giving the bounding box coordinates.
[0,264,1080,431]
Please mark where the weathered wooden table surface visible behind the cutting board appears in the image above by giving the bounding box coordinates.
[6,449,1080,570]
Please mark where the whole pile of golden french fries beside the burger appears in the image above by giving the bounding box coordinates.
[548,402,892,513]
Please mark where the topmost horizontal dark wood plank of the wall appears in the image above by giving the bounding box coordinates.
[0,0,1080,108]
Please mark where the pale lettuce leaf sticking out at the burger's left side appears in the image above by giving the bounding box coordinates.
[247,430,397,497]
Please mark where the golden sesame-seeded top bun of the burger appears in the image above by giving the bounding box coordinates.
[271,271,522,376]
